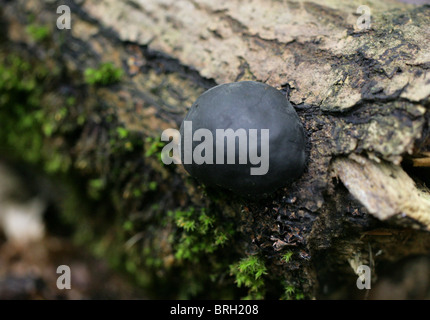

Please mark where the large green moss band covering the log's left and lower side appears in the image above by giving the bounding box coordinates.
[0,52,245,299]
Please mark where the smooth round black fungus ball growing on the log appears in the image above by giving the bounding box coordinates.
[180,81,306,195]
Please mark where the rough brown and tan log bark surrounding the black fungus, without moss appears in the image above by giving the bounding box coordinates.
[1,0,430,298]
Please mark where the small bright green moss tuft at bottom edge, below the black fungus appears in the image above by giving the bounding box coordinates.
[230,256,267,299]
